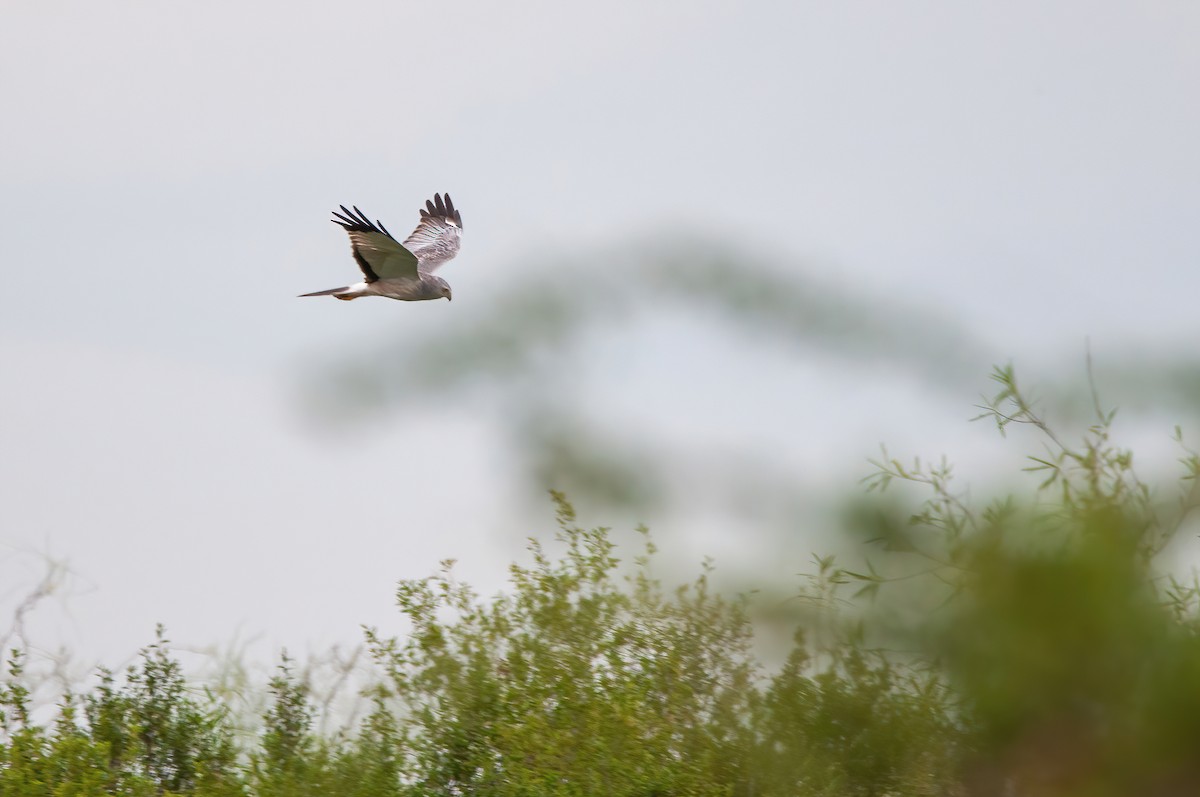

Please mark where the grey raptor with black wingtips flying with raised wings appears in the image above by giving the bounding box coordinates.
[300,193,462,301]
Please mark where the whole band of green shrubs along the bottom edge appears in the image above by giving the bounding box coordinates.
[7,367,1200,797]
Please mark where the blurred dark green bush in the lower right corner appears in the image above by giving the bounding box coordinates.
[859,367,1200,795]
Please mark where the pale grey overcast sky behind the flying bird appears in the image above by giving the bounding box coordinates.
[0,0,1200,663]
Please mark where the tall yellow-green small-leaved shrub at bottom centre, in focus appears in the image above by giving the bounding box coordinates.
[371,497,757,795]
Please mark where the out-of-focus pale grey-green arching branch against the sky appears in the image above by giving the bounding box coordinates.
[307,241,1200,528]
